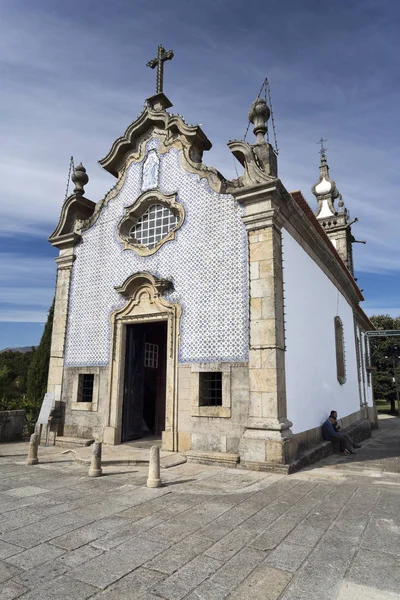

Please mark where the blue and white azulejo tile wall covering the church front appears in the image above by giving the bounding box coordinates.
[65,139,248,366]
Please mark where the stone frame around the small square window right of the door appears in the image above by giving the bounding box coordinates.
[191,363,231,419]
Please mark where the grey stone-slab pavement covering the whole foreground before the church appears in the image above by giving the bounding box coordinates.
[0,419,400,600]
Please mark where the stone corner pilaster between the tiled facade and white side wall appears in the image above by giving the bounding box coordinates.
[236,185,297,469]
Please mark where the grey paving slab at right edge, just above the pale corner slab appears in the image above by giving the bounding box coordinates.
[346,548,400,593]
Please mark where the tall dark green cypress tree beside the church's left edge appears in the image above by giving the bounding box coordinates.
[27,300,54,408]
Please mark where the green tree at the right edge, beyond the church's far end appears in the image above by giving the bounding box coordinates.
[371,315,400,413]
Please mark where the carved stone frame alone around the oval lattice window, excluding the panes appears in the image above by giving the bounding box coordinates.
[118,190,185,256]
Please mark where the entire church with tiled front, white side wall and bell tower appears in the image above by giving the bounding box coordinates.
[48,49,375,470]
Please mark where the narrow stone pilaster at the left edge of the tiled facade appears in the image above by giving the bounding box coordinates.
[47,246,75,401]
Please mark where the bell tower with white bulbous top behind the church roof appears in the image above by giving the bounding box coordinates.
[311,138,365,275]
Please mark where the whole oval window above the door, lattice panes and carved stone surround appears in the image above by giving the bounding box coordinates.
[117,190,185,256]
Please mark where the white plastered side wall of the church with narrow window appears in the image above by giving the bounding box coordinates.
[282,229,360,433]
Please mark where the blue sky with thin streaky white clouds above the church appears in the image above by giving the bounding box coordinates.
[0,0,400,349]
